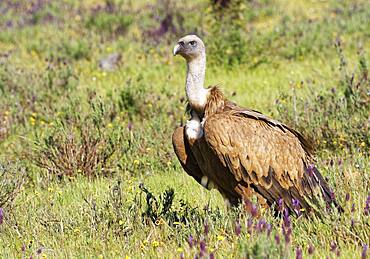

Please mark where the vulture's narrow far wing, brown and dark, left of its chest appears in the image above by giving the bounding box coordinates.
[172,127,204,184]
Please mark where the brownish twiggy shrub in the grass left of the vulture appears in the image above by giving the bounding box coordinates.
[32,99,124,177]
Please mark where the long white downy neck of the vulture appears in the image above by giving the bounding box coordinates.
[186,53,208,115]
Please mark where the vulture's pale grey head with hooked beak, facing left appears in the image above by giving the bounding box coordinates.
[173,35,206,62]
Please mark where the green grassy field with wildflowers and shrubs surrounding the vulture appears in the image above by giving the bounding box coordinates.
[0,0,370,258]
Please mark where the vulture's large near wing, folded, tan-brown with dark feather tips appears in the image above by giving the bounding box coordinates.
[204,107,331,212]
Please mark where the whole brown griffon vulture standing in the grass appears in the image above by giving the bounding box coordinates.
[172,35,339,214]
